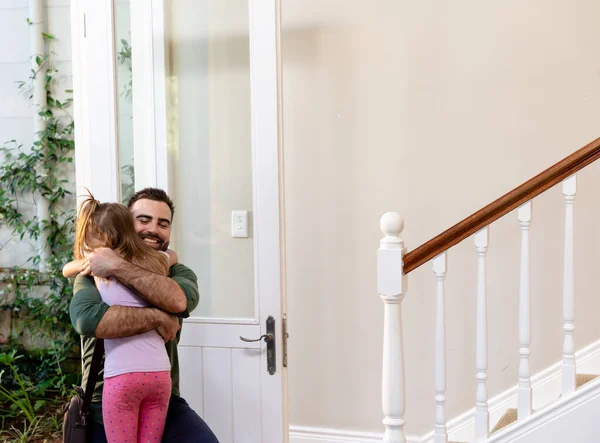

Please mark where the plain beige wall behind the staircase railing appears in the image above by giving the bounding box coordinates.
[283,0,600,434]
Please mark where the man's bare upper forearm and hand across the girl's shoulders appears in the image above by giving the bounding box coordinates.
[89,248,188,315]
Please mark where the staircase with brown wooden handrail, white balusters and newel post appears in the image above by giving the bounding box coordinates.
[377,139,600,443]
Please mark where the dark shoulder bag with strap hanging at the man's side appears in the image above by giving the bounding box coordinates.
[63,338,104,443]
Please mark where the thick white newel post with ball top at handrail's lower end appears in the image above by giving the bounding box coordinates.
[377,212,406,443]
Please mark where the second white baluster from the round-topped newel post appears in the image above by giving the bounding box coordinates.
[475,228,490,442]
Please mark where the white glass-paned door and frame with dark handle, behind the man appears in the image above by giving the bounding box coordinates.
[71,0,287,443]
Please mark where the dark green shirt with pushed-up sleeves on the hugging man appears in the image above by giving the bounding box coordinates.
[70,263,199,423]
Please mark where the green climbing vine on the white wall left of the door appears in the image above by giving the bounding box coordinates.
[0,33,77,362]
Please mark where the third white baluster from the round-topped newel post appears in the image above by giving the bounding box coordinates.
[517,202,532,419]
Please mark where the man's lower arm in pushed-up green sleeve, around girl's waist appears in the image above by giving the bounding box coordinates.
[69,275,179,341]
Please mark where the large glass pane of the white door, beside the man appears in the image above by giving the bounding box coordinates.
[167,0,255,318]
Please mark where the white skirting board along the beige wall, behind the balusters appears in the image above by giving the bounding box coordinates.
[289,340,600,443]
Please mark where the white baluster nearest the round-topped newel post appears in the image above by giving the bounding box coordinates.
[433,252,448,443]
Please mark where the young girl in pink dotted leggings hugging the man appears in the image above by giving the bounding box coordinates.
[63,194,176,443]
